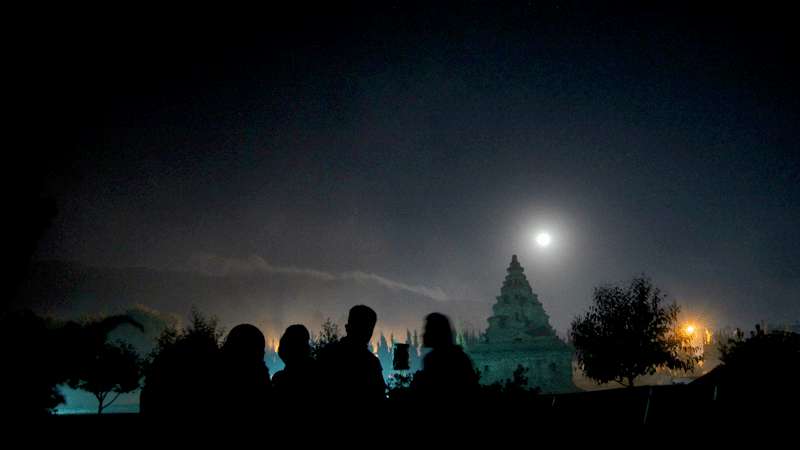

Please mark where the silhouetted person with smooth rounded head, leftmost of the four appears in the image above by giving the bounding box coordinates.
[216,324,271,416]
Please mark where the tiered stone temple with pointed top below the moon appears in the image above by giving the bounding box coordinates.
[468,255,576,393]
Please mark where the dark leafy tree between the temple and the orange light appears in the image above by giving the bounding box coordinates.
[570,277,700,387]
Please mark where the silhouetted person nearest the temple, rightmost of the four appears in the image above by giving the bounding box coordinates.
[411,313,478,402]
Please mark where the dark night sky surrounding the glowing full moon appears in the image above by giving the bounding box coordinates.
[16,2,800,330]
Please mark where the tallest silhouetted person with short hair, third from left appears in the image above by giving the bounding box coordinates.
[320,305,386,407]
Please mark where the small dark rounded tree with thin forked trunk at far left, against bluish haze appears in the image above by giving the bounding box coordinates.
[69,342,142,414]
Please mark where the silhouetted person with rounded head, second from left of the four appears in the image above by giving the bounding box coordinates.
[272,325,319,407]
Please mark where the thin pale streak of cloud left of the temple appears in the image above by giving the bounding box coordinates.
[189,254,449,301]
